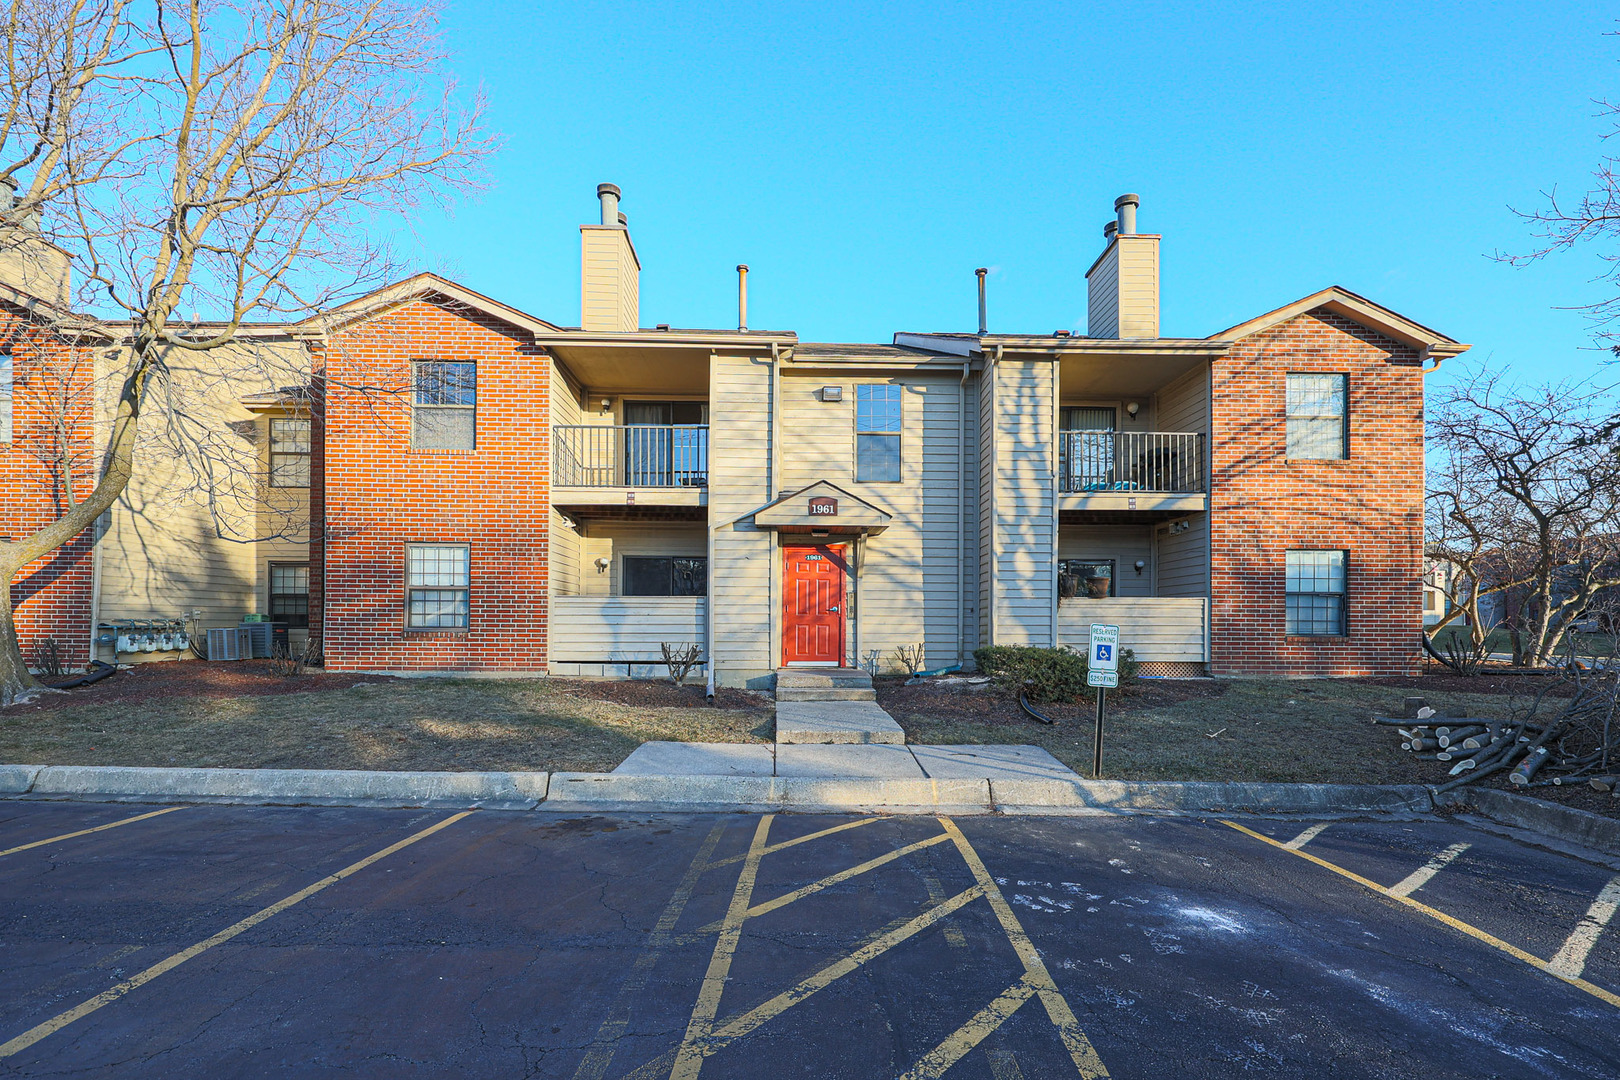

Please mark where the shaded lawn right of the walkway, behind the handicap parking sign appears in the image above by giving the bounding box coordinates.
[878,678,1548,784]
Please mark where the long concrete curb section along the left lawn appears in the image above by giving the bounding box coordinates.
[22,766,549,810]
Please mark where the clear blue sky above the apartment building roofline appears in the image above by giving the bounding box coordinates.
[401,0,1620,393]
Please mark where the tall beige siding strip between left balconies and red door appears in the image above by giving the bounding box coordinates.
[710,355,778,687]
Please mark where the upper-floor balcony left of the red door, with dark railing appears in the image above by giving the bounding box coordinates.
[551,424,708,507]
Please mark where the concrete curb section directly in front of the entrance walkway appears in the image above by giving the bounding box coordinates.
[539,772,991,814]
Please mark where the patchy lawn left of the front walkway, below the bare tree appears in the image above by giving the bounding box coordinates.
[0,662,773,772]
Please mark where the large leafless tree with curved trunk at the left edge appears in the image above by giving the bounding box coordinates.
[0,0,491,703]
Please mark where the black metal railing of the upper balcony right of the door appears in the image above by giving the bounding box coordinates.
[1058,431,1204,494]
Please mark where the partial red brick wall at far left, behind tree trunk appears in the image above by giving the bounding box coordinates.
[0,304,96,667]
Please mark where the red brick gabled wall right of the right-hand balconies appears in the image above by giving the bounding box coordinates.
[1210,309,1424,677]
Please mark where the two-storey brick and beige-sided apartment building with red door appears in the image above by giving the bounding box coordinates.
[0,185,1468,687]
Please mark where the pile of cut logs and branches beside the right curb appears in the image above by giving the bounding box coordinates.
[1372,688,1620,798]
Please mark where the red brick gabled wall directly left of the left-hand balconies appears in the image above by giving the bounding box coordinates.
[311,298,551,672]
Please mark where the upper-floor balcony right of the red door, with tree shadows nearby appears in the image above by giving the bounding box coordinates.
[1058,431,1209,512]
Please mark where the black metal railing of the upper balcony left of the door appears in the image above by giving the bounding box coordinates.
[551,424,708,487]
